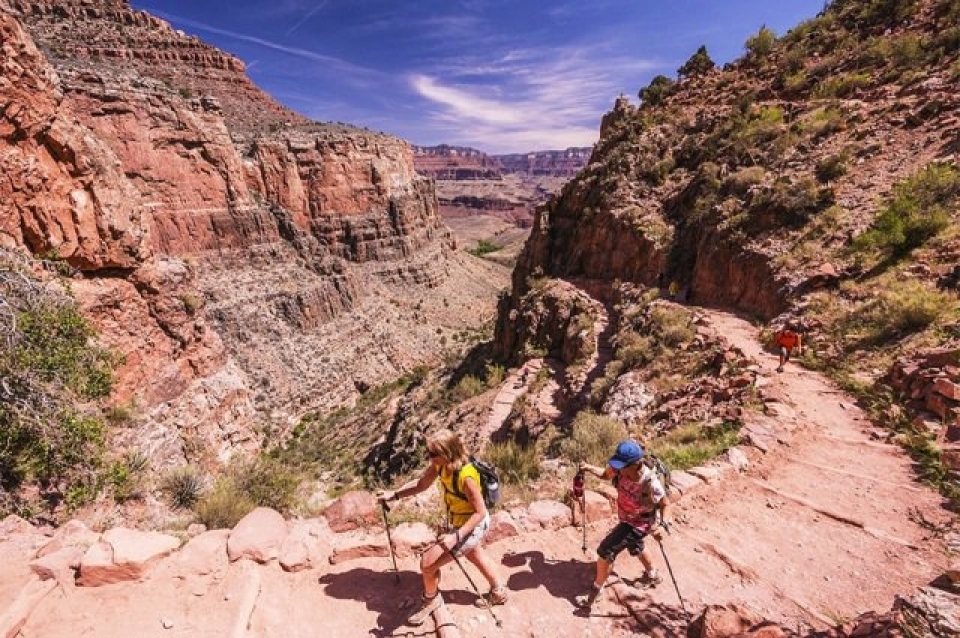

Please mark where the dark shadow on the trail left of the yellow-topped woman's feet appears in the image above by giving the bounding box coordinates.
[317,568,435,638]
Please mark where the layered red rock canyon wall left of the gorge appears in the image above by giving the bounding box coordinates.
[0,0,506,516]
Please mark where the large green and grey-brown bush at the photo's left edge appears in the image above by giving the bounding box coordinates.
[0,252,117,516]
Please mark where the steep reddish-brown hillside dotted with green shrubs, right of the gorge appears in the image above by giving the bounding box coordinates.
[497,0,960,430]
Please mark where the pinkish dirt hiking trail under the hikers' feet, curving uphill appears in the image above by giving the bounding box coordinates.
[0,310,949,638]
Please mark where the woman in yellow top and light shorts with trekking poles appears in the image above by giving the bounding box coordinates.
[379,430,507,626]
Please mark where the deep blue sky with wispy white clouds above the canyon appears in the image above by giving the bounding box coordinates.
[131,0,825,153]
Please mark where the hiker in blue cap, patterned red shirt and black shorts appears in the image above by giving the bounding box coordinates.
[576,439,670,608]
